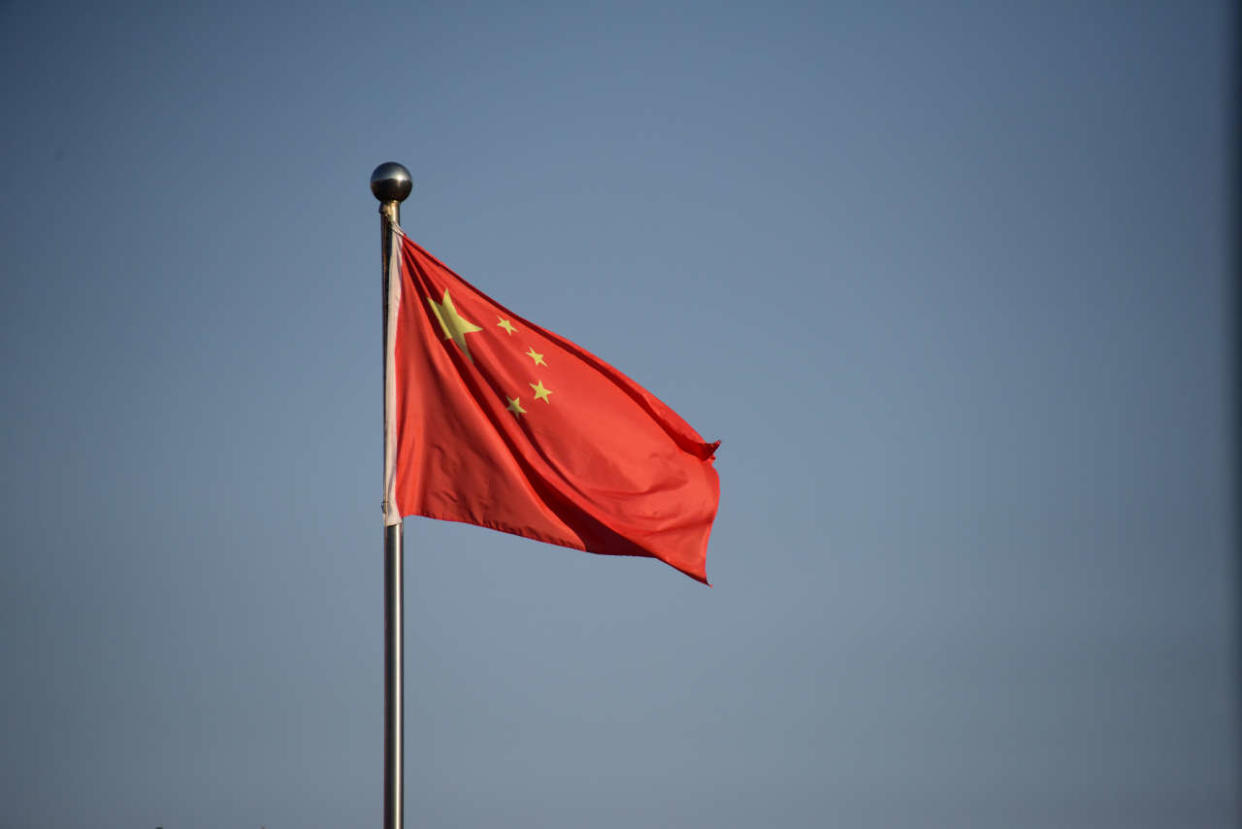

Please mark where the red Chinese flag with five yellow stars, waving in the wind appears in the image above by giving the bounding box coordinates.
[386,231,720,584]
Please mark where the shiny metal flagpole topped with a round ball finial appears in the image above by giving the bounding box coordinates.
[371,162,414,829]
